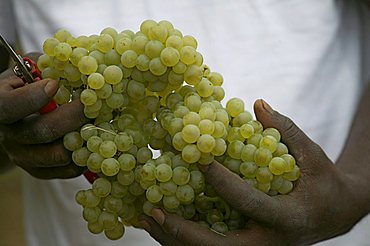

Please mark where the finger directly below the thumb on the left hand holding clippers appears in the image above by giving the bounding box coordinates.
[6,100,89,144]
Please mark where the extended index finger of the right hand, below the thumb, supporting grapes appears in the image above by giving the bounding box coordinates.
[202,161,285,225]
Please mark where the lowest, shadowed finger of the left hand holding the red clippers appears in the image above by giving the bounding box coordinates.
[22,163,86,179]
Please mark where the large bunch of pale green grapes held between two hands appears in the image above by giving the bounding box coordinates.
[37,20,300,240]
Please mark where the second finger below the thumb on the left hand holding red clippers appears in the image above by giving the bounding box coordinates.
[4,139,72,167]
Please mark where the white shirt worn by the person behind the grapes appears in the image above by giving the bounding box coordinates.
[0,0,370,246]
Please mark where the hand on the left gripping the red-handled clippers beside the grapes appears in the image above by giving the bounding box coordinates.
[0,64,87,179]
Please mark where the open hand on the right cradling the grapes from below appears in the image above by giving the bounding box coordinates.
[139,100,366,245]
